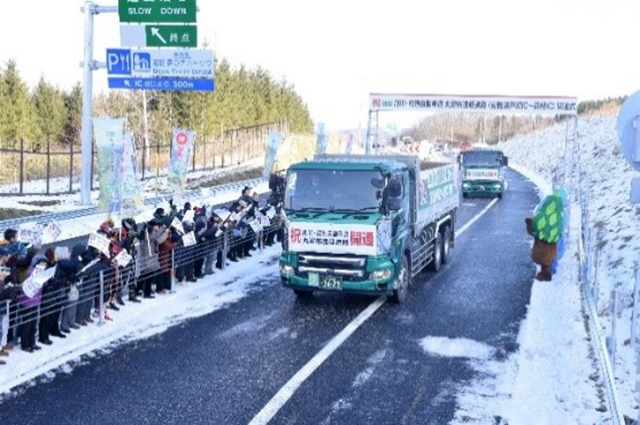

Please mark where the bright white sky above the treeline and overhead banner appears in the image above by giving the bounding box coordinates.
[0,0,640,129]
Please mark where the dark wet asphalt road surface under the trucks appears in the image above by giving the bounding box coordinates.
[0,172,537,425]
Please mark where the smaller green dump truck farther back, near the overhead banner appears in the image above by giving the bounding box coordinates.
[460,148,509,198]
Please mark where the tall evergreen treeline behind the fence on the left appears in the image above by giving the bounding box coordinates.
[0,60,313,150]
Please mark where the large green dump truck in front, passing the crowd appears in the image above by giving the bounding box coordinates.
[280,155,459,302]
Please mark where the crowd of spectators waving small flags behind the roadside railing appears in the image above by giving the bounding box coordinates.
[0,187,282,365]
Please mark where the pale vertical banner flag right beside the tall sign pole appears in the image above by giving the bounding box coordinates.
[93,118,125,214]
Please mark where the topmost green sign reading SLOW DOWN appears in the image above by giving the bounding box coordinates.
[118,0,197,23]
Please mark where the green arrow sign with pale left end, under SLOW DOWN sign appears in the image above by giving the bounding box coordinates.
[120,25,198,47]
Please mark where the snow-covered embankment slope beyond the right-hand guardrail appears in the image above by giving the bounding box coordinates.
[503,115,640,418]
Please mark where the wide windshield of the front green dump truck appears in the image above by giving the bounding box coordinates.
[285,170,382,212]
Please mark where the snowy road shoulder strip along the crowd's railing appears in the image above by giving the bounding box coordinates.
[0,246,280,396]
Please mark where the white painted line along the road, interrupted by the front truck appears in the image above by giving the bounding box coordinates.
[249,199,498,425]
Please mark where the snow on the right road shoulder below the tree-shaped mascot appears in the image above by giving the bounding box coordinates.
[448,171,608,425]
